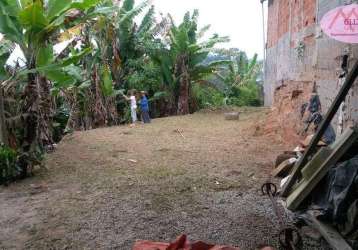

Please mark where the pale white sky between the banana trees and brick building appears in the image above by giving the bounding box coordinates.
[152,0,264,58]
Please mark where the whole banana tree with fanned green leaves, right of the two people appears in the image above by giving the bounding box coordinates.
[151,10,229,115]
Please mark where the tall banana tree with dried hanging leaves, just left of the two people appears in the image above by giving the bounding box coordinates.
[73,0,152,127]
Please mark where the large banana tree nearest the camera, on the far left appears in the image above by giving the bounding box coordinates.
[0,0,110,174]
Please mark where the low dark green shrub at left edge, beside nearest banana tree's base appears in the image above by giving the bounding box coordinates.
[0,145,20,185]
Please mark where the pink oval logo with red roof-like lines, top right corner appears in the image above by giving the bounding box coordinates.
[321,4,358,43]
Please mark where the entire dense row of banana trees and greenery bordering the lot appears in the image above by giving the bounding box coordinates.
[0,0,260,184]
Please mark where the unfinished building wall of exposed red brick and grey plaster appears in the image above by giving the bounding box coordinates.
[264,0,358,142]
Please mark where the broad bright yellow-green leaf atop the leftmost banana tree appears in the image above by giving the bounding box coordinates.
[19,2,48,32]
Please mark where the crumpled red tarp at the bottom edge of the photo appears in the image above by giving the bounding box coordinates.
[133,235,240,250]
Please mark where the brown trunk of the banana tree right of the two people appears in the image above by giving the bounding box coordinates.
[175,55,190,115]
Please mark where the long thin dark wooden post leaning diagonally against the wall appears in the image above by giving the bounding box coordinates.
[281,61,358,197]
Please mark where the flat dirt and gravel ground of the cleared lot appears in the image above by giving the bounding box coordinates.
[0,109,328,250]
